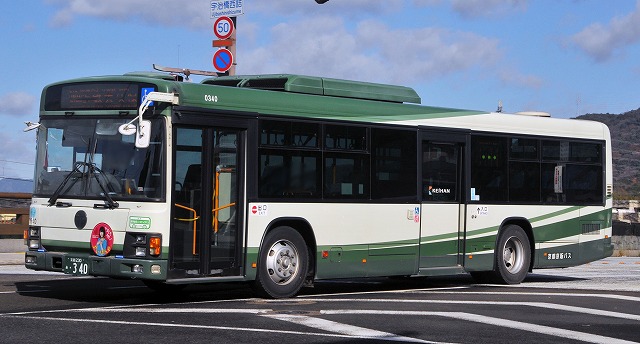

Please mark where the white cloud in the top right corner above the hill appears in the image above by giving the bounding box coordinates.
[571,1,640,62]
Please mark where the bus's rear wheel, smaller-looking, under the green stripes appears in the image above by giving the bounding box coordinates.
[494,225,531,284]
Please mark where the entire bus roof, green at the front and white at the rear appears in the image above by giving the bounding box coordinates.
[41,72,608,141]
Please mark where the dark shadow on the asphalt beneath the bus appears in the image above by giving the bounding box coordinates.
[14,274,585,305]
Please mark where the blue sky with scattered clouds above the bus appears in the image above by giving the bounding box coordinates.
[0,0,640,179]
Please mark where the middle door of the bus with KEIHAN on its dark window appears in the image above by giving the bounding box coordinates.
[420,132,465,273]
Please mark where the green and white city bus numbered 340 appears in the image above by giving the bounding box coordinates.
[25,72,613,298]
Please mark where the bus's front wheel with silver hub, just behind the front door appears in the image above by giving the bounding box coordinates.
[253,226,309,298]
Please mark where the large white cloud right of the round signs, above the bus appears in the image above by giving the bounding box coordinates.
[238,17,501,83]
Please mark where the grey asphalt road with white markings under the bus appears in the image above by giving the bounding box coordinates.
[0,258,640,344]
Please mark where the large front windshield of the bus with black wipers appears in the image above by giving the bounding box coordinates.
[34,118,165,201]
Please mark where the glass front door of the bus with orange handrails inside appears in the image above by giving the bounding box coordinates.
[169,125,246,278]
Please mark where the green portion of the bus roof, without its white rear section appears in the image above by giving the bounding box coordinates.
[41,72,486,122]
